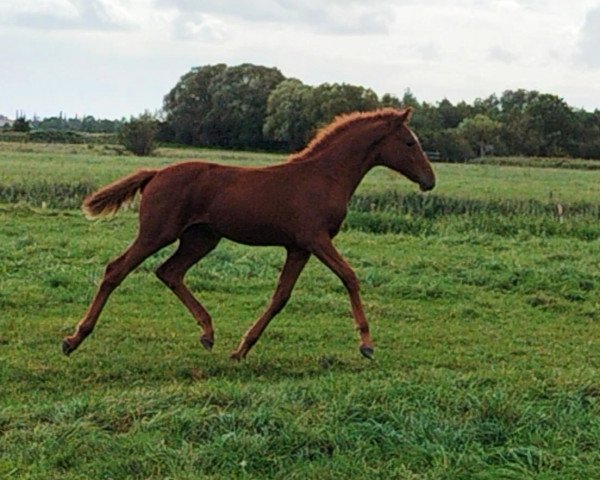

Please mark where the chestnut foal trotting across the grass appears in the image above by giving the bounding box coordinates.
[63,108,435,360]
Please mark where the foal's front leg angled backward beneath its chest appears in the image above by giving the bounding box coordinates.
[231,249,310,360]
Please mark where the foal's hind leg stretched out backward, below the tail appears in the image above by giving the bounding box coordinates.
[63,236,171,355]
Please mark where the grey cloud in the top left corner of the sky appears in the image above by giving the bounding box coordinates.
[0,0,130,30]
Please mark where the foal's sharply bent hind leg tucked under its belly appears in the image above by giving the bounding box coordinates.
[156,225,220,350]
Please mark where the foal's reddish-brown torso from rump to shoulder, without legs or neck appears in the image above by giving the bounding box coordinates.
[140,161,345,245]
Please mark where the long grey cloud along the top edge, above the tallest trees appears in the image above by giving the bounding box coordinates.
[155,0,394,35]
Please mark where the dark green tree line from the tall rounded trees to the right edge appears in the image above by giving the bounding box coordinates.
[160,64,600,161]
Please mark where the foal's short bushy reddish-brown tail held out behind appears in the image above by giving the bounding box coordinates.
[81,170,158,218]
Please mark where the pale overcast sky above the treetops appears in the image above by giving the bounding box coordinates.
[0,0,600,118]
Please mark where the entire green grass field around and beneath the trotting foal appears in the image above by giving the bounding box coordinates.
[0,144,600,479]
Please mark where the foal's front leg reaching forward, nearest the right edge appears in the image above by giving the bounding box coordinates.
[311,235,373,359]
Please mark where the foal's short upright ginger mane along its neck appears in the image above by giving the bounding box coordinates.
[288,108,407,162]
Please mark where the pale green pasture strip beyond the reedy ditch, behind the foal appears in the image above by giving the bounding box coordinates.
[0,142,600,203]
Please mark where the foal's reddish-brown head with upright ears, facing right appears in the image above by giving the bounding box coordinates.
[375,108,435,192]
